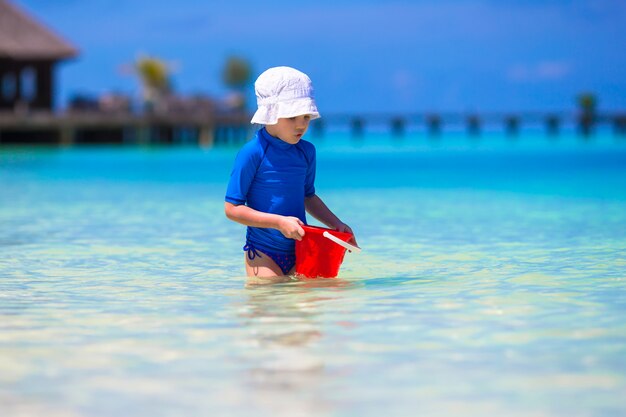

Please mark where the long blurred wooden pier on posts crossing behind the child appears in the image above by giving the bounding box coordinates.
[0,112,626,147]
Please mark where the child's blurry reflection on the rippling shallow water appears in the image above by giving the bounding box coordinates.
[240,280,343,415]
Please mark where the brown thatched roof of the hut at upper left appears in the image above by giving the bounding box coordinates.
[0,0,78,60]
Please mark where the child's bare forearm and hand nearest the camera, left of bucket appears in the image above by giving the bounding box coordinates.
[224,202,304,240]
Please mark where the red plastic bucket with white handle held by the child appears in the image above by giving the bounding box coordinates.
[296,226,352,278]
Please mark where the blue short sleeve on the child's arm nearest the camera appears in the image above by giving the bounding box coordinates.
[225,141,261,205]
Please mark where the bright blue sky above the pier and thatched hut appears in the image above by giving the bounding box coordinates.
[13,0,626,113]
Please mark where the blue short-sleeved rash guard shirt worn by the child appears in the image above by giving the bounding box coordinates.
[225,128,316,254]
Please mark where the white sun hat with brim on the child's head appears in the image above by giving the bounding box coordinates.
[250,67,320,125]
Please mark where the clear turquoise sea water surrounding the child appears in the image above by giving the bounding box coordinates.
[0,134,626,417]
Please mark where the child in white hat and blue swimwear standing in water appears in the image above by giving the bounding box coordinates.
[224,67,352,277]
